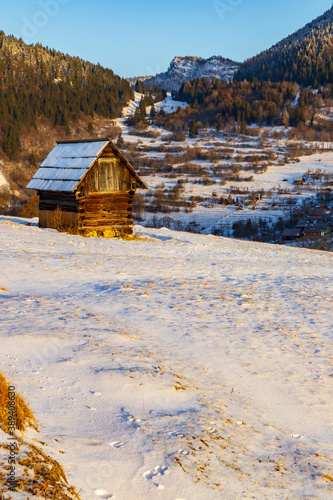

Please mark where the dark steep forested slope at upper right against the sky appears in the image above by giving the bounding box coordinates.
[236,7,333,87]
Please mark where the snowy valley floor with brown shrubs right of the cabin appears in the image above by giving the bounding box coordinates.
[103,93,333,249]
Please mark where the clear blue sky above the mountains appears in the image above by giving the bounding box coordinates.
[0,0,332,77]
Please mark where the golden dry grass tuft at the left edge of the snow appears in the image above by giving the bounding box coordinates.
[0,372,37,432]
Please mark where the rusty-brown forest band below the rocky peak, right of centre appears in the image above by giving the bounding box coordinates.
[155,78,333,133]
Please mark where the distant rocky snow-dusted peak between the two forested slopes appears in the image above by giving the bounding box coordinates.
[127,56,240,91]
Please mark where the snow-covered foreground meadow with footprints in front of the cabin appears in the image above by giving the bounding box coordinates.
[0,217,333,500]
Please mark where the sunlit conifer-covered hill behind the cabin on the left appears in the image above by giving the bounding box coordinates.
[0,32,133,157]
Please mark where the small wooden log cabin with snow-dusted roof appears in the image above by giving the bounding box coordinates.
[27,138,147,236]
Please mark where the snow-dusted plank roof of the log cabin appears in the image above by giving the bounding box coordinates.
[27,137,147,193]
